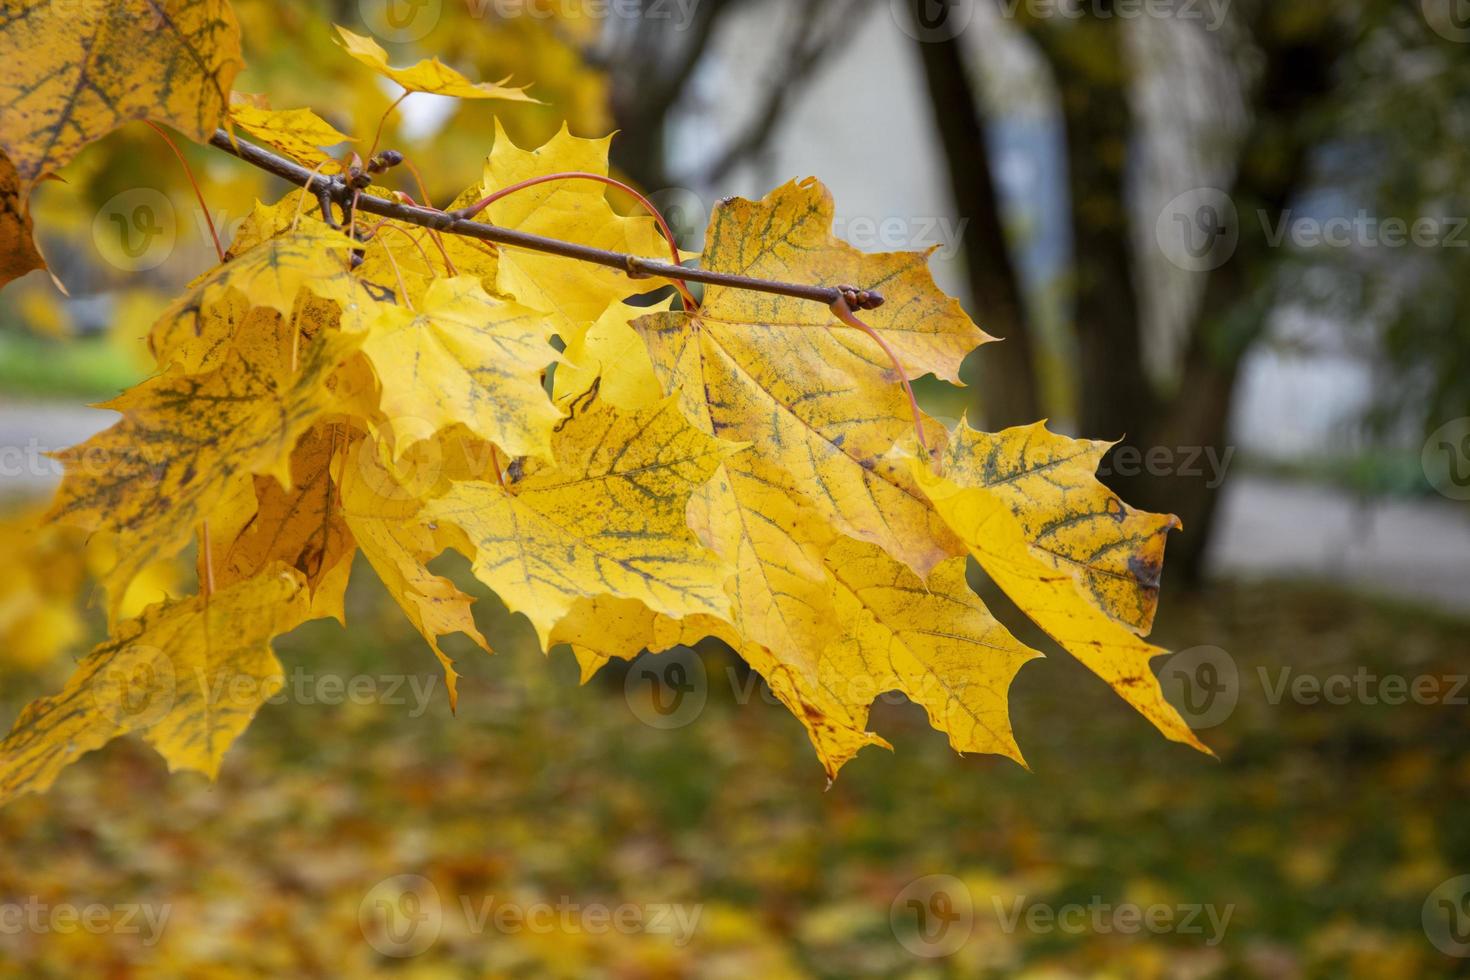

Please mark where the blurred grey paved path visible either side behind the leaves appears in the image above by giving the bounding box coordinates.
[0,400,1470,610]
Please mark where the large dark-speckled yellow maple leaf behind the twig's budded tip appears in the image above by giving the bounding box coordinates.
[634,182,964,576]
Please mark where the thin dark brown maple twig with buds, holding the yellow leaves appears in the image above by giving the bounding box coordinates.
[209,129,883,310]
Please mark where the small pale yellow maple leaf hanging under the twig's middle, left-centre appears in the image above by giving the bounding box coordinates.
[363,276,562,455]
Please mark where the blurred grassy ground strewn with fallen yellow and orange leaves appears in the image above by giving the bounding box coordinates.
[0,569,1470,977]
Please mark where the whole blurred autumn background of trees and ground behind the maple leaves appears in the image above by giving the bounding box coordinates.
[0,0,1470,977]
